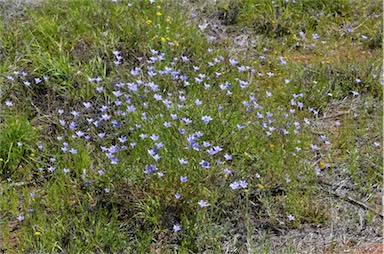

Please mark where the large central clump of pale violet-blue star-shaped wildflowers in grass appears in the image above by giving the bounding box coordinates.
[5,41,331,226]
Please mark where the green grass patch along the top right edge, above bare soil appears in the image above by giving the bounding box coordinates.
[234,0,382,42]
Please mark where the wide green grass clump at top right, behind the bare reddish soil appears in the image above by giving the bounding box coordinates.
[217,0,383,48]
